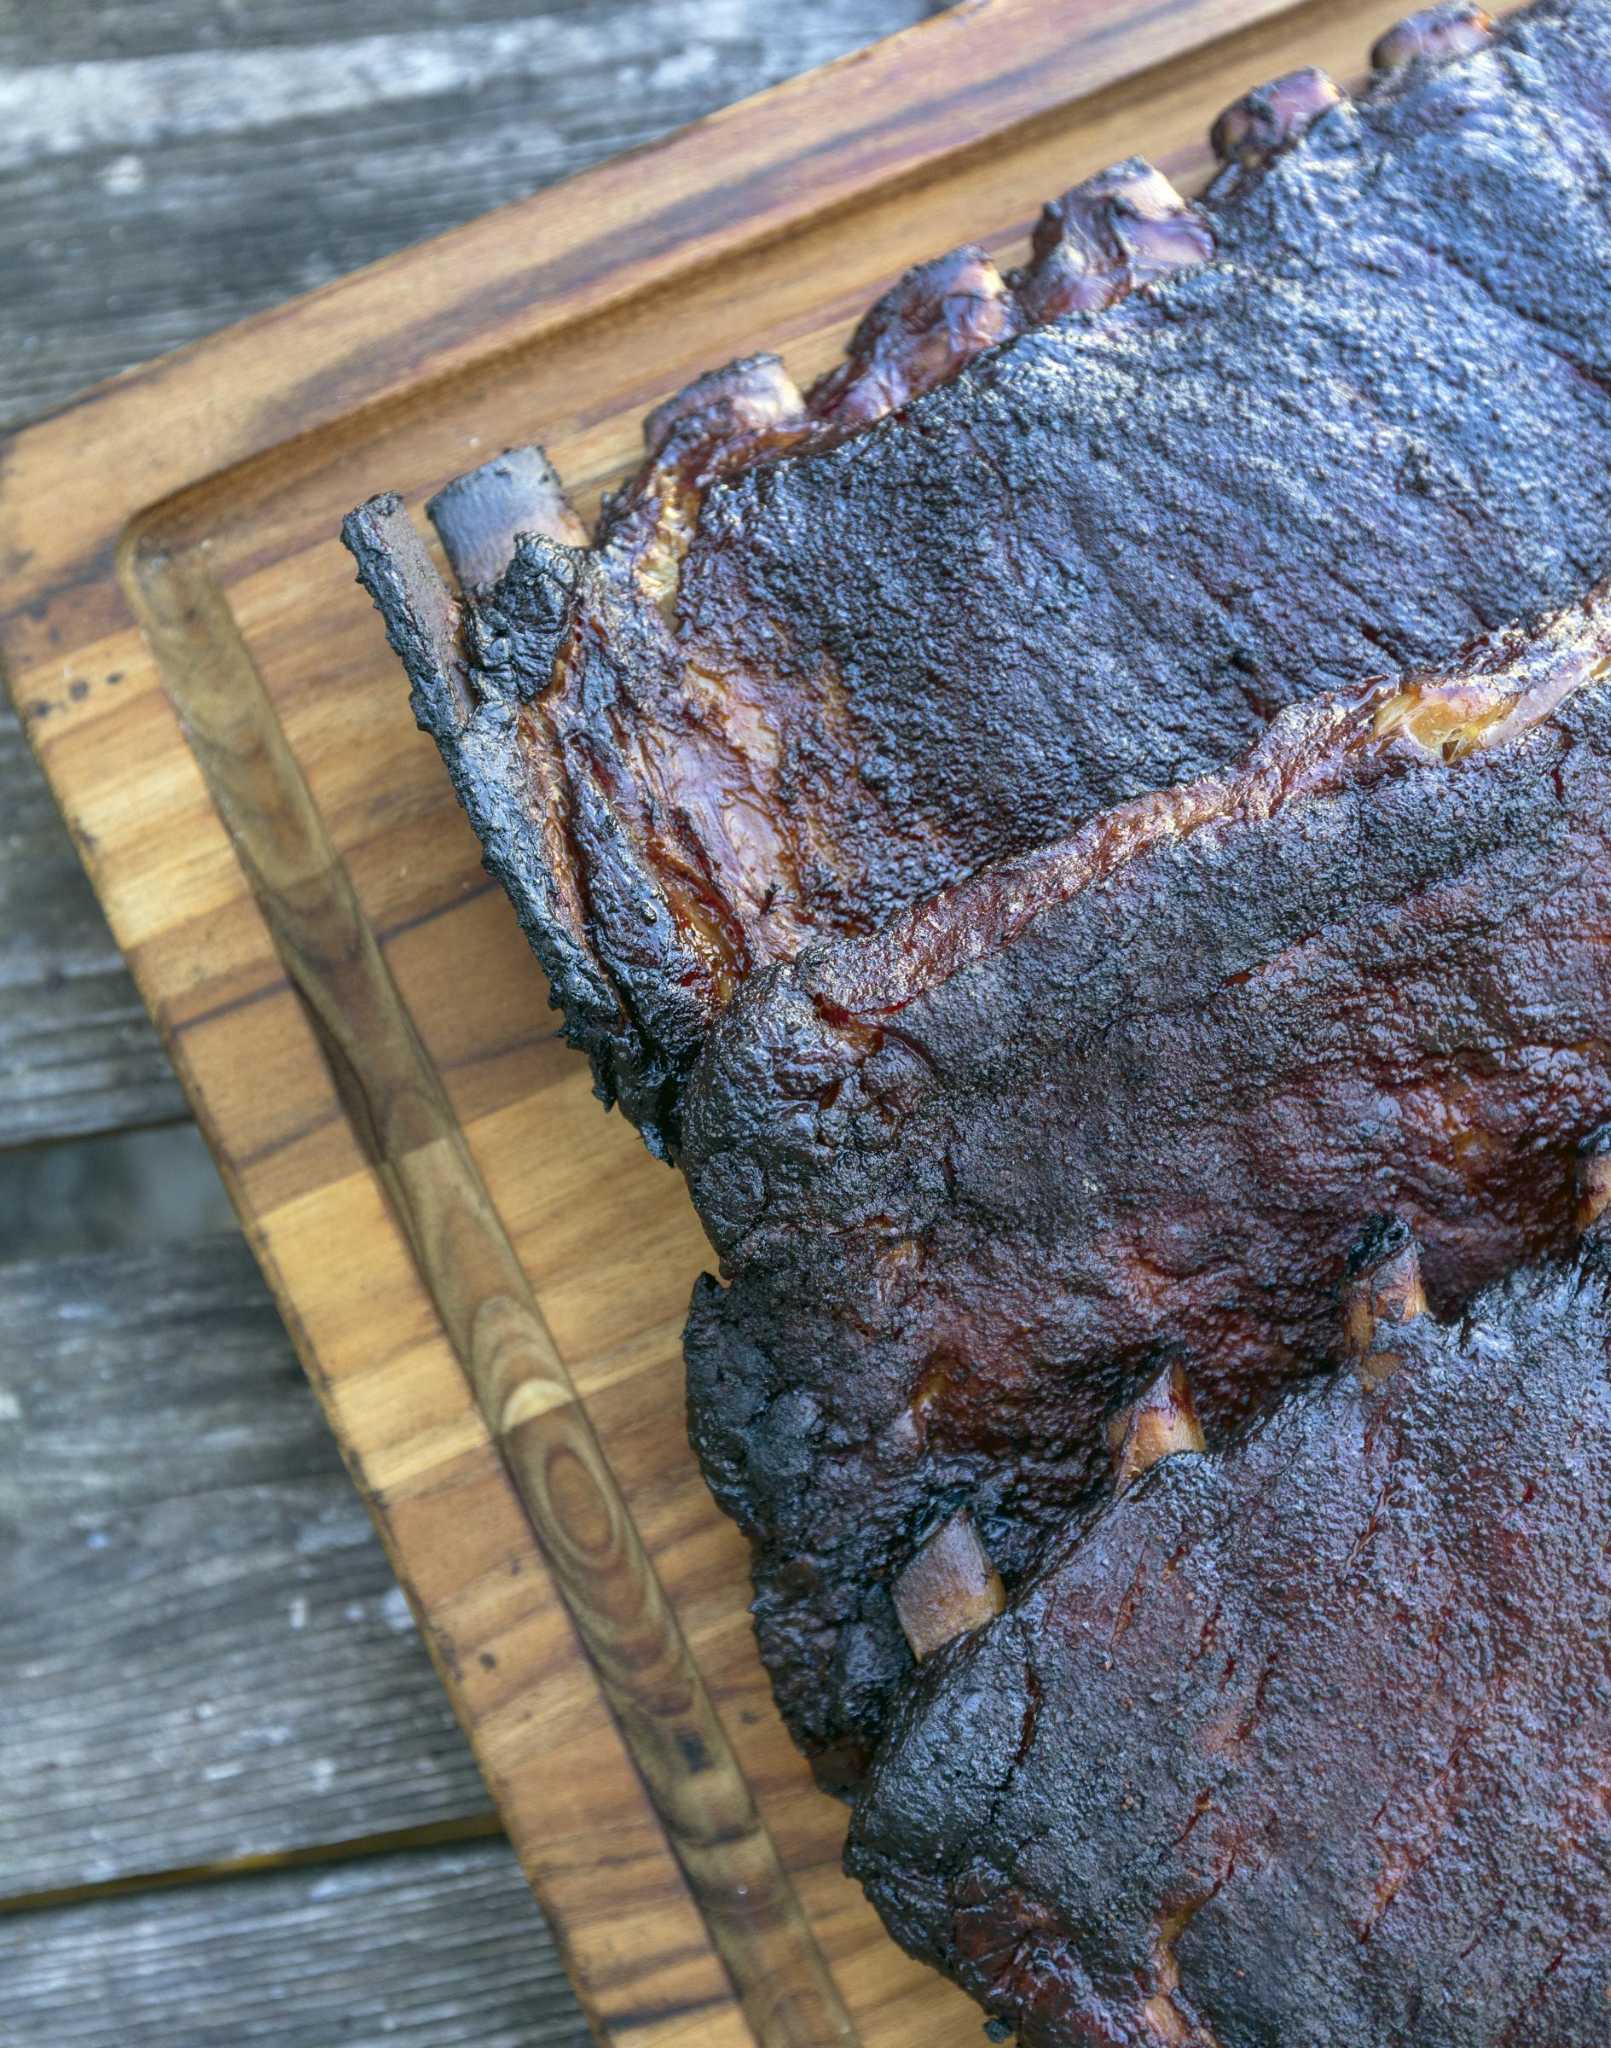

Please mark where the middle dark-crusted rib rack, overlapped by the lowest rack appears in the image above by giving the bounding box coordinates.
[684,590,1611,1782]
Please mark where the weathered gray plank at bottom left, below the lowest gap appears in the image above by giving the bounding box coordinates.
[0,1841,590,2048]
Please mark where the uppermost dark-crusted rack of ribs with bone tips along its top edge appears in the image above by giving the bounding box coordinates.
[350,0,1611,1153]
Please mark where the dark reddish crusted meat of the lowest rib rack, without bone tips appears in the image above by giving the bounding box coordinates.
[847,1204,1611,2048]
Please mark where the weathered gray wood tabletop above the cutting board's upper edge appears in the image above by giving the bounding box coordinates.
[0,0,933,426]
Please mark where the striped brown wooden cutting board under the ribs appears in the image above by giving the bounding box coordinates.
[0,0,1432,2048]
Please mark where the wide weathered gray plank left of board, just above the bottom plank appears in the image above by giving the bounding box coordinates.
[0,1237,489,1892]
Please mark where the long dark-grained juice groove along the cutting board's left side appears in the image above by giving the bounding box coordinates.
[127,539,856,2048]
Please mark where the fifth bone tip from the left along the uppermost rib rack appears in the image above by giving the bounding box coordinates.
[1013,156,1214,324]
